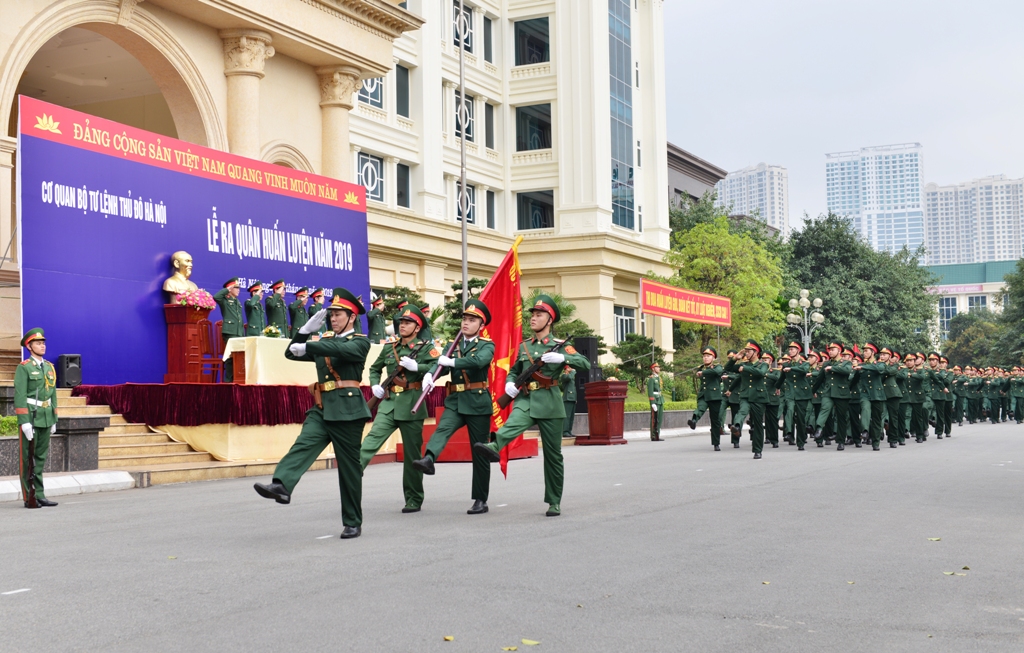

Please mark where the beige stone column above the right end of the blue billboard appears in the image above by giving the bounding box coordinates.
[316,66,362,182]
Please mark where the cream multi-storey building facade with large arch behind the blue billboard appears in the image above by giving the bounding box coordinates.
[0,0,672,364]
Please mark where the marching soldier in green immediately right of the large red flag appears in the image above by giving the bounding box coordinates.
[473,295,590,517]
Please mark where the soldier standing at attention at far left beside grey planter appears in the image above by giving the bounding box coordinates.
[14,329,57,508]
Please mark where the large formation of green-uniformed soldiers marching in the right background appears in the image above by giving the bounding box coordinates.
[688,341,1024,459]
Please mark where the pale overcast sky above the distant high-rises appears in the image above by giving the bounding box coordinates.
[665,0,1024,227]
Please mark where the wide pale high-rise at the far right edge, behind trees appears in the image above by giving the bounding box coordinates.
[925,175,1024,265]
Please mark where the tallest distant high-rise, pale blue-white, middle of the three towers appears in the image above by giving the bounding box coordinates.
[825,143,925,252]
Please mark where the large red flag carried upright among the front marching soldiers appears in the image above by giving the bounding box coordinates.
[480,235,522,476]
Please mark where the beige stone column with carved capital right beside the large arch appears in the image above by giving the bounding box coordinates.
[218,30,273,159]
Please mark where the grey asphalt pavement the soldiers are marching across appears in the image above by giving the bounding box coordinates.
[0,424,1024,653]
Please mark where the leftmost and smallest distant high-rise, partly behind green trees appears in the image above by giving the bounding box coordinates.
[716,163,790,238]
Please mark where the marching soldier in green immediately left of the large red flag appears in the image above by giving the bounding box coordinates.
[413,299,497,515]
